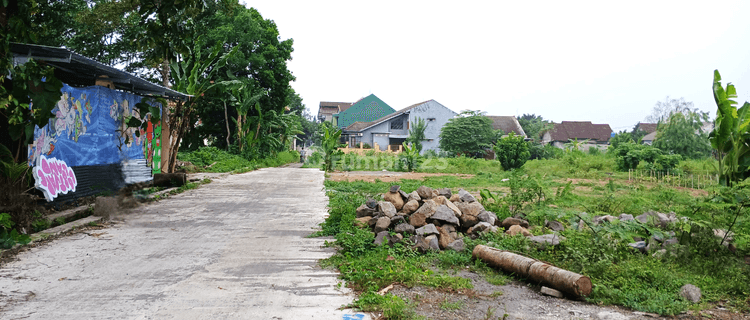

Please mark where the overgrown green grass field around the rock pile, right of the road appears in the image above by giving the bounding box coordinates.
[317,154,750,319]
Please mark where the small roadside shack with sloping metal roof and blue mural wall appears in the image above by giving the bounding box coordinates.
[11,44,190,201]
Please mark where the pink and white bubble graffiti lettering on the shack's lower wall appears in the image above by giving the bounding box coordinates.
[32,155,78,201]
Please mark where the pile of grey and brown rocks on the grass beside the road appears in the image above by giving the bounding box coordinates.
[355,185,559,252]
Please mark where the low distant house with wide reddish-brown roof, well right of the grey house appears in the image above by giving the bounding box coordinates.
[542,121,613,150]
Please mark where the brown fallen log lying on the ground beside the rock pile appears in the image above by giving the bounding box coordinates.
[472,245,591,297]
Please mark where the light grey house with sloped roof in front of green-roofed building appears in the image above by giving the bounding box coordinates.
[342,100,458,152]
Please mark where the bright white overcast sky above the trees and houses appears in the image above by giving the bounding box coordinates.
[245,0,750,131]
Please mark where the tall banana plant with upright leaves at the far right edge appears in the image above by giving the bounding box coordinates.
[708,70,750,186]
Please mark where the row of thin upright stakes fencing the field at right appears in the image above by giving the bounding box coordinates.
[628,169,719,189]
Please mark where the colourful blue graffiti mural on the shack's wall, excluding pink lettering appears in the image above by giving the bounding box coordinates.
[28,85,159,201]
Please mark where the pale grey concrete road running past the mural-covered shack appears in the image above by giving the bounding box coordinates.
[0,168,368,320]
